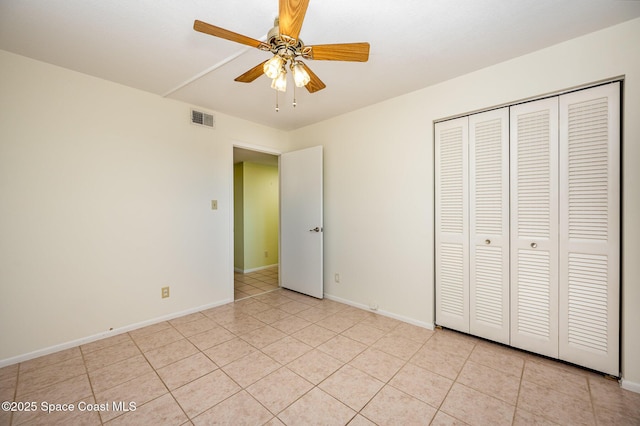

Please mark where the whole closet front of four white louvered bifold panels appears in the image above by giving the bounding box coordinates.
[435,82,620,376]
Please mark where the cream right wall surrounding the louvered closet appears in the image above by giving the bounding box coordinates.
[290,19,640,392]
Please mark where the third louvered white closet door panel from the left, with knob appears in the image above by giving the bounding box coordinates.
[510,98,558,358]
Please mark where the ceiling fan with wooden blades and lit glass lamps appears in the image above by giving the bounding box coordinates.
[193,0,369,95]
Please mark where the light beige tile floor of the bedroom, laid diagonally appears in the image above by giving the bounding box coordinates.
[0,289,640,426]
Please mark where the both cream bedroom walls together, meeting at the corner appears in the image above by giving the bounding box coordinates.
[0,19,640,391]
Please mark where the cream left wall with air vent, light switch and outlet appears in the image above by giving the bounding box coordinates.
[0,51,287,366]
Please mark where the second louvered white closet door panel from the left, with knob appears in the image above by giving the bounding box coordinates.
[469,107,509,344]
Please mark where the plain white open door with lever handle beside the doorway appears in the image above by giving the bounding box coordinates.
[280,146,324,299]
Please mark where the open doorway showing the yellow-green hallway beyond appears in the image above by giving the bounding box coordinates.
[233,146,280,301]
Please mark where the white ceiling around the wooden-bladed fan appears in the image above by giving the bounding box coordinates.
[0,0,640,130]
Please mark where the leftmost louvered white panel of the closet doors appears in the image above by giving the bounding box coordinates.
[435,117,469,332]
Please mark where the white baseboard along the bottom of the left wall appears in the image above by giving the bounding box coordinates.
[0,299,233,368]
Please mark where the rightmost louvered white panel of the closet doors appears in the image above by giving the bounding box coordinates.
[560,82,620,376]
